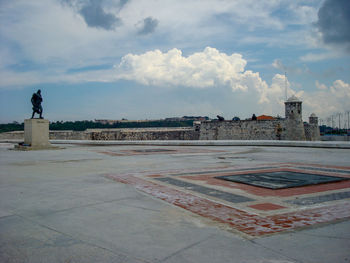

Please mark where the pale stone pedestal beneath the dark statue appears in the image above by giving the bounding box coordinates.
[24,119,51,148]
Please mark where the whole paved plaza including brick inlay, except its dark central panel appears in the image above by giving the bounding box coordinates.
[0,143,350,263]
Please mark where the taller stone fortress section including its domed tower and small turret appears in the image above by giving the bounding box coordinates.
[197,96,320,141]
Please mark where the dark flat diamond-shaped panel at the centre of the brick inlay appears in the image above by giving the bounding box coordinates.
[215,171,348,189]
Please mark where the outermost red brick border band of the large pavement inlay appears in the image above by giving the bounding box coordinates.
[105,174,350,236]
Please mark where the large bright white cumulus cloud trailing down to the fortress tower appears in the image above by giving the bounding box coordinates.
[115,47,314,117]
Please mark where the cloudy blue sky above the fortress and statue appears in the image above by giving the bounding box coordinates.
[0,0,350,123]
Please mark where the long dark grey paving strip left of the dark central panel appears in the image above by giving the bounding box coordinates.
[155,177,254,203]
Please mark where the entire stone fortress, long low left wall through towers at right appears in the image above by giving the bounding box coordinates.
[0,96,321,141]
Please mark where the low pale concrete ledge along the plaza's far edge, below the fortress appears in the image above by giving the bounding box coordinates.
[50,140,350,149]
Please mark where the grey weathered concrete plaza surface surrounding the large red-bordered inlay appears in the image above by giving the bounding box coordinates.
[0,143,350,263]
